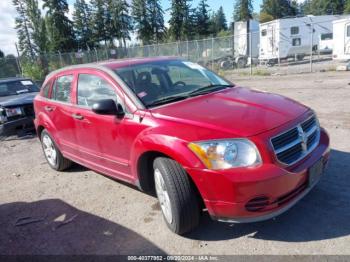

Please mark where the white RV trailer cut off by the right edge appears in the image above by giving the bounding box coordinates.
[333,17,350,61]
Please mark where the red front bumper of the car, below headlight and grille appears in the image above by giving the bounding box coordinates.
[187,130,330,223]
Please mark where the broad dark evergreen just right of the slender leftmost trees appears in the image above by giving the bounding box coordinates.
[43,0,75,52]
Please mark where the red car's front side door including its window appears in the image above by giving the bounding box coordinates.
[74,70,135,181]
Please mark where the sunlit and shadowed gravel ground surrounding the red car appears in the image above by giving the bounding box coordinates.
[0,70,350,255]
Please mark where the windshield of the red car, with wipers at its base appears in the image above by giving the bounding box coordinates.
[114,60,232,108]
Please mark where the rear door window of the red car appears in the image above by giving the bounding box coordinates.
[51,75,74,103]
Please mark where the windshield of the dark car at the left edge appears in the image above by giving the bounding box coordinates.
[0,80,39,96]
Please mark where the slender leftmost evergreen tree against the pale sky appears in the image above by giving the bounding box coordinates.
[13,0,35,59]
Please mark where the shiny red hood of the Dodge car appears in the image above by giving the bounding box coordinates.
[151,87,308,137]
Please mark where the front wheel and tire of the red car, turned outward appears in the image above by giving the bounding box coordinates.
[153,157,200,235]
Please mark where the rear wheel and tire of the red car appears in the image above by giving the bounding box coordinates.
[40,129,72,171]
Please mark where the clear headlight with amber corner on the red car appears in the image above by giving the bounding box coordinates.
[188,139,261,170]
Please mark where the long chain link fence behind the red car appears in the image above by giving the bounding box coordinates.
[0,17,348,80]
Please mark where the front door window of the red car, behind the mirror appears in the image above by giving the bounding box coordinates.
[77,74,118,107]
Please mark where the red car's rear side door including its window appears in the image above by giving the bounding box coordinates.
[44,72,78,155]
